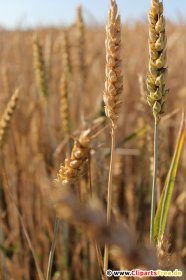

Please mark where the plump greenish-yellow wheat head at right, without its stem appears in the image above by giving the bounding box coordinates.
[147,0,169,119]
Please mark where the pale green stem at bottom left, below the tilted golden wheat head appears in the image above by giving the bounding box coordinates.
[46,217,59,280]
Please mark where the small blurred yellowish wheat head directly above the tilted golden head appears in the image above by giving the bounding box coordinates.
[60,72,70,134]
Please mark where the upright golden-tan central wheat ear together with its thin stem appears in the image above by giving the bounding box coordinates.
[103,0,123,271]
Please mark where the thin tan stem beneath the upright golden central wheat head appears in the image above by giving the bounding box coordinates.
[104,125,115,272]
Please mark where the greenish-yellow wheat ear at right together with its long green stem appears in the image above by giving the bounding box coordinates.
[147,0,169,242]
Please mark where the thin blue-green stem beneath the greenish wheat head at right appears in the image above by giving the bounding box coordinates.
[150,119,158,243]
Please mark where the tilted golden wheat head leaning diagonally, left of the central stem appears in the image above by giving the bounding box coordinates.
[57,129,91,184]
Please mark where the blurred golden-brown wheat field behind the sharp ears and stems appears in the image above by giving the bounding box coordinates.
[0,3,186,280]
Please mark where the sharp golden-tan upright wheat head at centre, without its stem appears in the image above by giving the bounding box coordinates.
[103,0,123,126]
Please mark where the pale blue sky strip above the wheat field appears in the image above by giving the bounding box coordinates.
[0,0,186,28]
